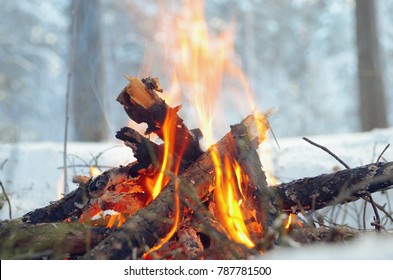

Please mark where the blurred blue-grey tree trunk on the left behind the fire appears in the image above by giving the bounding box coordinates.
[71,0,108,141]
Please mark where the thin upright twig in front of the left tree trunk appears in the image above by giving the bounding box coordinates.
[63,0,79,193]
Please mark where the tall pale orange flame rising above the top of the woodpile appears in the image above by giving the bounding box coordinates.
[162,0,239,145]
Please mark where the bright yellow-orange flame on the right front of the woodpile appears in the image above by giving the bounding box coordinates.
[210,146,255,248]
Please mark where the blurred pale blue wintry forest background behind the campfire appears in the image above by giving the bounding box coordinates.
[0,0,393,142]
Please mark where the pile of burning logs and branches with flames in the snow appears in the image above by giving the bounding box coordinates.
[0,77,393,259]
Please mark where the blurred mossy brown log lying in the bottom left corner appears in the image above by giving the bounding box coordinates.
[0,220,111,259]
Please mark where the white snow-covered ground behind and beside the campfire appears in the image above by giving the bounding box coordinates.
[0,128,393,259]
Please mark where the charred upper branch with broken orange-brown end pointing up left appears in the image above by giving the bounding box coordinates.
[117,76,202,165]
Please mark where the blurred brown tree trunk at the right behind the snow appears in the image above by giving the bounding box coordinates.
[356,0,387,131]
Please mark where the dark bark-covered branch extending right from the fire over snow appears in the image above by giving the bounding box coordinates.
[272,162,393,211]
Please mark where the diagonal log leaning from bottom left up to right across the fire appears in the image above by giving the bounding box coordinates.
[85,112,272,259]
